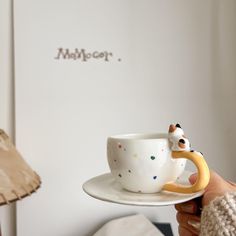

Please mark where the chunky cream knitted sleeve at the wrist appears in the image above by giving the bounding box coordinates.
[200,192,236,236]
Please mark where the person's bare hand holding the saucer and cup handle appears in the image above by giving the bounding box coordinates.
[175,171,236,236]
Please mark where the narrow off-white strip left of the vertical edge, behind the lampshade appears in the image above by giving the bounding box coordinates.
[0,0,16,236]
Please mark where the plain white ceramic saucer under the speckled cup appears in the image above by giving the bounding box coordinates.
[83,171,204,206]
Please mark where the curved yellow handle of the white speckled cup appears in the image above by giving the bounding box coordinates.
[163,151,210,193]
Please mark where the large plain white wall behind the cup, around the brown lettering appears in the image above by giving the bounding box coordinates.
[0,0,236,236]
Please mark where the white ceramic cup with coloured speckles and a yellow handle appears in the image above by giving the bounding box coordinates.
[107,134,210,193]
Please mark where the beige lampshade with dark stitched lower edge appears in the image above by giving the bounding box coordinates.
[0,129,41,205]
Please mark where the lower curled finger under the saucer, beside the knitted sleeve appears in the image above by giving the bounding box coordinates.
[176,212,200,234]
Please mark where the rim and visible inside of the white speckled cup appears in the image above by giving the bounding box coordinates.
[108,133,168,140]
